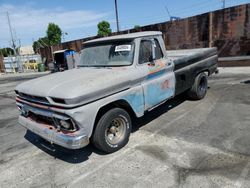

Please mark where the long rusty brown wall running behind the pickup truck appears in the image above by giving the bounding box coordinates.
[40,4,250,62]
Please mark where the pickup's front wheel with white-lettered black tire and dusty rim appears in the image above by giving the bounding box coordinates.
[92,108,132,153]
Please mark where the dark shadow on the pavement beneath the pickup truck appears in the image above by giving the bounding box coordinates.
[24,95,186,164]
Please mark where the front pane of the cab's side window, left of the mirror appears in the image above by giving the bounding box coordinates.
[139,40,152,64]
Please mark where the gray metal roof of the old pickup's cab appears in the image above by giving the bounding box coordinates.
[84,31,162,44]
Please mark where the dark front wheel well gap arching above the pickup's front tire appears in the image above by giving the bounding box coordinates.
[93,100,136,132]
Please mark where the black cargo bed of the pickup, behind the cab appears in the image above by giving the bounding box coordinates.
[167,48,218,95]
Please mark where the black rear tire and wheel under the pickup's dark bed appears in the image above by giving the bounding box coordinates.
[187,72,207,100]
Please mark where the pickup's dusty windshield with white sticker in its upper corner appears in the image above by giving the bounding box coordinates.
[79,41,134,67]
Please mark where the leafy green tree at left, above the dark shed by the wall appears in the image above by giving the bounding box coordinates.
[47,23,62,45]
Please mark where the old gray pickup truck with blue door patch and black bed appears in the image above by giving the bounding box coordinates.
[15,31,218,153]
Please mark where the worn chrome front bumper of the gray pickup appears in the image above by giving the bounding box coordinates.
[18,115,89,149]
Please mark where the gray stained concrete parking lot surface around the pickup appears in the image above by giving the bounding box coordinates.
[0,68,250,188]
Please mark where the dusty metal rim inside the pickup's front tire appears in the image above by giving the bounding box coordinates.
[105,116,128,145]
